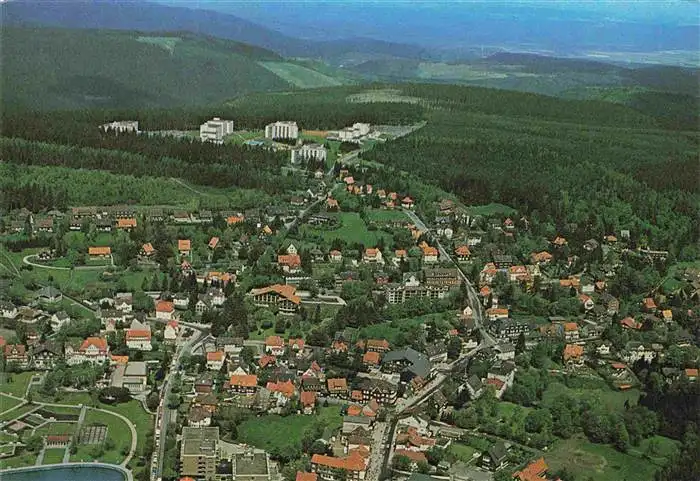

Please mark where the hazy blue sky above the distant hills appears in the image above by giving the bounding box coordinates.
[157,0,700,54]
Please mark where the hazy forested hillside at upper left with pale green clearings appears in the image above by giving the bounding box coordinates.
[0,28,302,109]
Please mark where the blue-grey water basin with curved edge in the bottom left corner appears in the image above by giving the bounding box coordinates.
[0,464,126,481]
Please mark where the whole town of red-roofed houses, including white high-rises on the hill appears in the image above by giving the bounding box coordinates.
[0,109,700,481]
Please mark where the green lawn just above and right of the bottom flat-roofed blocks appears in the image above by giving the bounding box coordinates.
[238,406,343,452]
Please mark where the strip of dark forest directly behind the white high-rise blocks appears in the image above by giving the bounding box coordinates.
[1,86,424,134]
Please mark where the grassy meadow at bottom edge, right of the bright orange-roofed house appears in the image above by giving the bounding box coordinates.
[545,438,657,481]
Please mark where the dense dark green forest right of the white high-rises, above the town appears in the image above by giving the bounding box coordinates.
[364,85,700,254]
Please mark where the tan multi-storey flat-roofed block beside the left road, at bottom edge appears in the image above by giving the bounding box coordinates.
[180,427,219,480]
